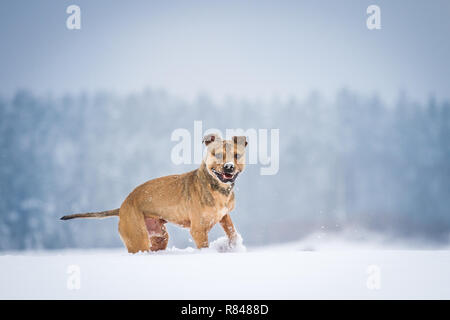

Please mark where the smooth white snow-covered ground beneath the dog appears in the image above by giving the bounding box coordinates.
[0,234,450,299]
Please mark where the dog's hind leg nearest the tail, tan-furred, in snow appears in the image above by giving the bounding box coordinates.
[119,204,150,253]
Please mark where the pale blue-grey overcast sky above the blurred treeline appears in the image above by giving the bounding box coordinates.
[0,0,450,100]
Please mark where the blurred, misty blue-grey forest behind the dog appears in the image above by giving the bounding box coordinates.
[0,90,450,250]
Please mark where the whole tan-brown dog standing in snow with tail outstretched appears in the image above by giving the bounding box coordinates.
[61,134,247,253]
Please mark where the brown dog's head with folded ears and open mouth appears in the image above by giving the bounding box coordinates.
[203,134,247,184]
